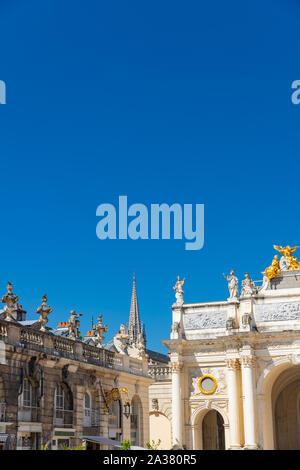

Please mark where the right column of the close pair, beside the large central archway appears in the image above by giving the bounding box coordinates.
[242,356,257,449]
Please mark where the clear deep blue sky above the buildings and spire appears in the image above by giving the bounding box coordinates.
[0,0,300,352]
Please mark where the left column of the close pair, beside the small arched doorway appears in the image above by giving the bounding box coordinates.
[226,359,241,449]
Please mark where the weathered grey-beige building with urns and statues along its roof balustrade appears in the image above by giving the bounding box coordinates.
[0,283,153,449]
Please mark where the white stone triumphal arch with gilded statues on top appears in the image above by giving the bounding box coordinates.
[149,246,300,449]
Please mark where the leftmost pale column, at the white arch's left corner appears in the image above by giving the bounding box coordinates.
[171,362,183,448]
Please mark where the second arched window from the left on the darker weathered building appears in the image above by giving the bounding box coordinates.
[54,384,73,427]
